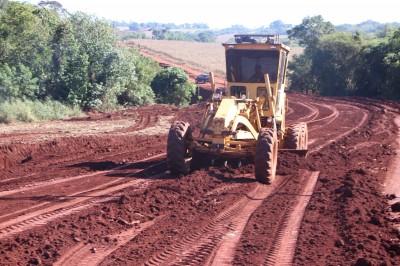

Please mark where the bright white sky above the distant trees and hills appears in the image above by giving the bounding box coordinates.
[15,0,400,28]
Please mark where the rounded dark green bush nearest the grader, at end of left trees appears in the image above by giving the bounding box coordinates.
[151,67,196,106]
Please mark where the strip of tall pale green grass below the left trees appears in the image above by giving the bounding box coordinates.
[0,99,84,123]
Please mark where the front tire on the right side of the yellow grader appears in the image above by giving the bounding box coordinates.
[254,128,278,184]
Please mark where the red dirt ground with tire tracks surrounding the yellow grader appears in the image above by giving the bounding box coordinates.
[0,53,400,265]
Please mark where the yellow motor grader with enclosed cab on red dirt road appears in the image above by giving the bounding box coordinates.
[167,34,308,184]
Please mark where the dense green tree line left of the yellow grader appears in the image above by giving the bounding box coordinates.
[0,0,194,121]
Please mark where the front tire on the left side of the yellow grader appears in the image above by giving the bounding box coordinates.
[167,121,192,174]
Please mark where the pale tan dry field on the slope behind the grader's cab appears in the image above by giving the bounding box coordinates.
[129,39,302,77]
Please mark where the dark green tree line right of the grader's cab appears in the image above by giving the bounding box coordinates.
[288,16,400,100]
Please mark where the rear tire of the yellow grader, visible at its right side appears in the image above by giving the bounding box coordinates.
[285,123,308,150]
